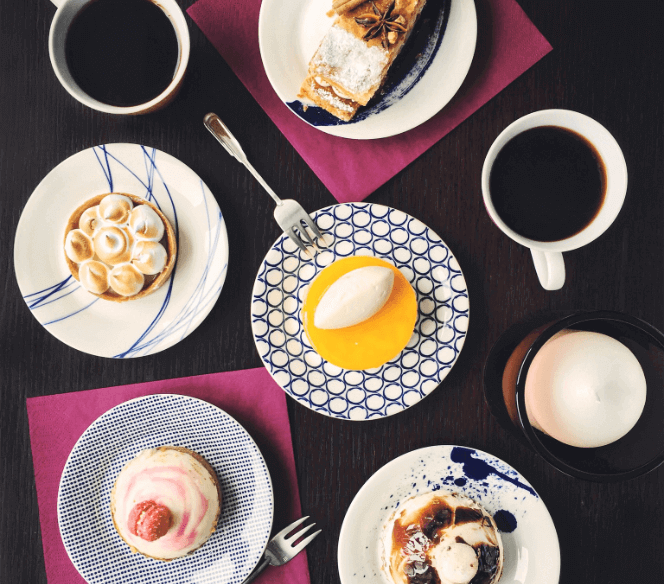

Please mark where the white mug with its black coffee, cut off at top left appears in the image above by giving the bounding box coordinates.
[48,0,190,115]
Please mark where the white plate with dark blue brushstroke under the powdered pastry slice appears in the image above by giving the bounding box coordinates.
[258,0,477,139]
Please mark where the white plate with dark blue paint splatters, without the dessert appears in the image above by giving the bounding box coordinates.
[338,445,560,584]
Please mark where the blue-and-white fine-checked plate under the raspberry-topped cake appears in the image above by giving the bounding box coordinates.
[58,394,274,584]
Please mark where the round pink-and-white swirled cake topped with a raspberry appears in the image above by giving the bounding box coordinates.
[111,446,221,561]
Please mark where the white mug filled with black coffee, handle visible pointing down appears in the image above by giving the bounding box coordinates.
[482,109,627,290]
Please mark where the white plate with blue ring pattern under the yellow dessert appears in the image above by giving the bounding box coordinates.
[251,203,469,420]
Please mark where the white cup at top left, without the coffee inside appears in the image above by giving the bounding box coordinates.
[48,0,190,115]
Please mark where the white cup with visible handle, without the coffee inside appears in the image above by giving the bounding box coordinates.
[482,109,627,290]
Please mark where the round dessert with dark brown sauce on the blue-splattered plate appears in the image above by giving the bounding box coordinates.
[381,491,503,584]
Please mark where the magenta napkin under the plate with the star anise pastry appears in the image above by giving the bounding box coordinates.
[187,0,551,203]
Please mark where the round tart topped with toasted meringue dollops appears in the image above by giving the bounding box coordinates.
[64,193,177,302]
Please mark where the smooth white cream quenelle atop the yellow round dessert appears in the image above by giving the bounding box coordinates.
[314,266,394,329]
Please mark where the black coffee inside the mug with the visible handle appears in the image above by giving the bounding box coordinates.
[489,126,606,241]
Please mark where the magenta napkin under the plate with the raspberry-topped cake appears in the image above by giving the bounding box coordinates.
[27,368,309,584]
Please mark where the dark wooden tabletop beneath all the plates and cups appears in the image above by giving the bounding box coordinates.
[0,0,664,584]
